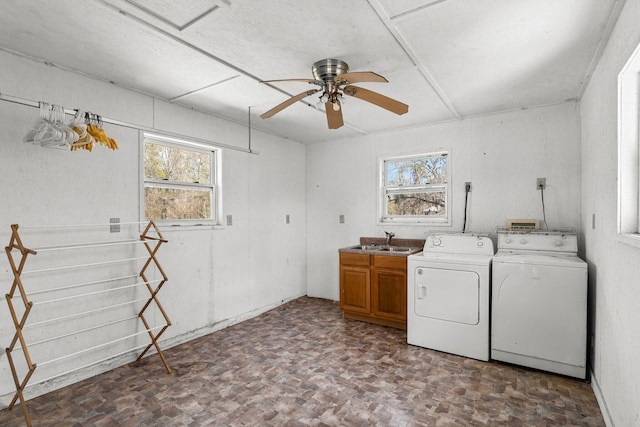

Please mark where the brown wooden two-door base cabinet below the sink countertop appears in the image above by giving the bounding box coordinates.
[340,253,407,329]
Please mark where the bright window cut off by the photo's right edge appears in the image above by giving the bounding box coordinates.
[618,40,640,247]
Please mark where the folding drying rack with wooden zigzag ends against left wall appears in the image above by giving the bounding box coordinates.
[5,221,171,426]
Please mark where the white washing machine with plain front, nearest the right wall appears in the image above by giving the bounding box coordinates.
[491,229,587,379]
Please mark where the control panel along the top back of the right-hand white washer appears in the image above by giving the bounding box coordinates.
[498,231,578,252]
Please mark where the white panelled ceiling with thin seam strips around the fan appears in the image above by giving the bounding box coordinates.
[0,0,624,143]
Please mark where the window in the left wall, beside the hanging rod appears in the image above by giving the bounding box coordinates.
[142,134,220,225]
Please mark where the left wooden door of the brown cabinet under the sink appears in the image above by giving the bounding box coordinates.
[340,266,371,314]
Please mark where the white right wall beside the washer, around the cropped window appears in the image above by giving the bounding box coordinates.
[581,0,640,426]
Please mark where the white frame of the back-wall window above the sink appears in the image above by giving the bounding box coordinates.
[377,149,452,226]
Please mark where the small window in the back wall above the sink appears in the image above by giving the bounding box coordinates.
[379,151,450,224]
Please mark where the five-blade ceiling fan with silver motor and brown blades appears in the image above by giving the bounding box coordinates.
[260,59,409,129]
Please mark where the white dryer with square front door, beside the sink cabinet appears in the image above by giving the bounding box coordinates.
[407,233,493,360]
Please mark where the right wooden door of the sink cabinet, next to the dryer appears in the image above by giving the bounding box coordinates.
[372,268,407,321]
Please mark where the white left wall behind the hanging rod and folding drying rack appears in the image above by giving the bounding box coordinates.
[0,52,306,407]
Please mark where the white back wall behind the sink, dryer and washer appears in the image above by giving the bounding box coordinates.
[307,103,580,300]
